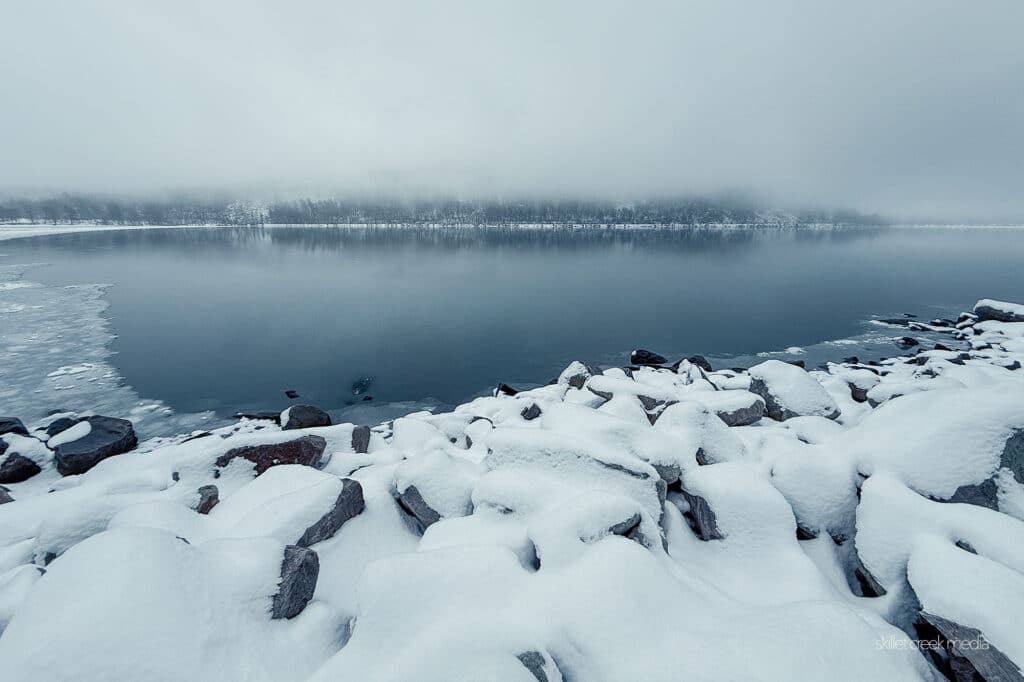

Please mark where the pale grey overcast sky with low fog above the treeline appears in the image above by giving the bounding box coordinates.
[0,0,1024,219]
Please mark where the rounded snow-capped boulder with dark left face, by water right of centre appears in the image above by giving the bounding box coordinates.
[750,360,840,422]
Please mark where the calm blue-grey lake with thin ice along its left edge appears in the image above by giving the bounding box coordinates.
[0,227,1024,431]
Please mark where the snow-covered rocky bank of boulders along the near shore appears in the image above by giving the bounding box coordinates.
[0,301,1024,682]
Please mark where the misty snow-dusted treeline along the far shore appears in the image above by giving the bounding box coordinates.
[0,195,883,225]
